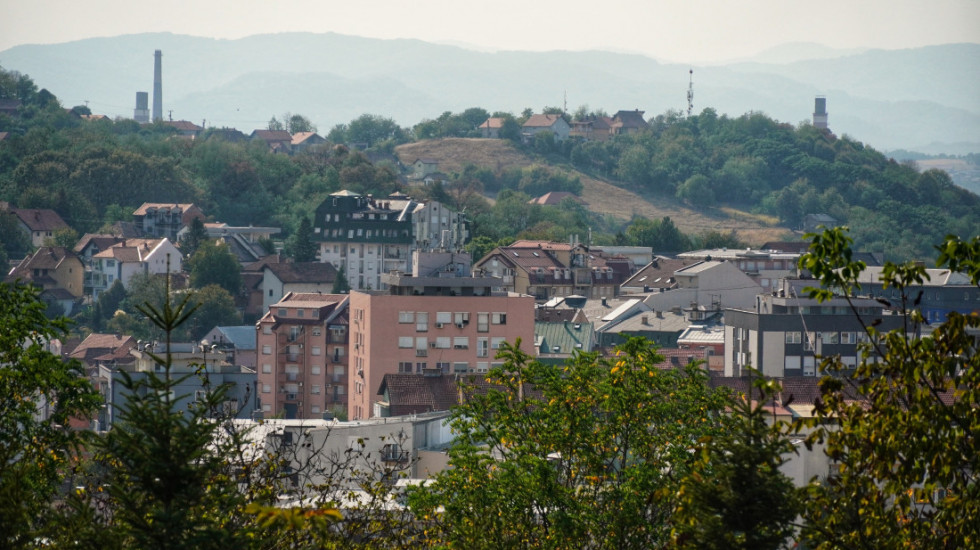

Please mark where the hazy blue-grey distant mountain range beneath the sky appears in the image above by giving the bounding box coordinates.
[0,33,980,154]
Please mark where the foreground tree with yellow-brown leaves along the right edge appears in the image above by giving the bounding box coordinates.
[799,228,980,548]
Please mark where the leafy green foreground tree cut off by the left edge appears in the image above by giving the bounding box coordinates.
[0,282,99,548]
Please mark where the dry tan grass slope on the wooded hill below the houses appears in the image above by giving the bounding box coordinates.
[395,138,789,245]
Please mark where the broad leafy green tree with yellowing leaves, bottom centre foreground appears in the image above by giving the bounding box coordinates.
[410,339,726,548]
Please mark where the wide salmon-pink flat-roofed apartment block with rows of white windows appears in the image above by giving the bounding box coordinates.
[347,273,534,420]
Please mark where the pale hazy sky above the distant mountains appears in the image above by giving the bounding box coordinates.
[0,0,980,63]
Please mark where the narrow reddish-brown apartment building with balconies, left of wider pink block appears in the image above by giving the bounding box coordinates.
[255,292,348,418]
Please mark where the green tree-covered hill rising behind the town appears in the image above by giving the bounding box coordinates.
[0,70,980,266]
